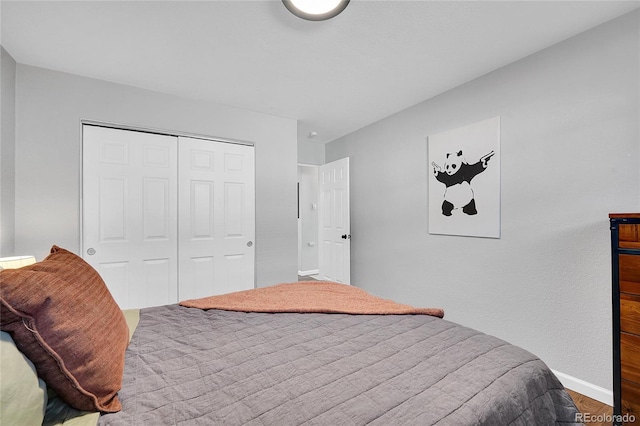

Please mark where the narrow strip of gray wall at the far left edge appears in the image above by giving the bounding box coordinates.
[0,46,16,256]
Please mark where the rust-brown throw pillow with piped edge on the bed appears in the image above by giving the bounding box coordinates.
[0,246,129,412]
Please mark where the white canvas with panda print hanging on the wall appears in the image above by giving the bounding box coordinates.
[427,117,500,238]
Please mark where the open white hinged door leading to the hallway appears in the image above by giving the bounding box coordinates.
[318,158,351,284]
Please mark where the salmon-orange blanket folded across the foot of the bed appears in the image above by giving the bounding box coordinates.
[180,281,444,318]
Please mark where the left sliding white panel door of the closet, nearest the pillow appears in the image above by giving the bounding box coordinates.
[82,125,178,309]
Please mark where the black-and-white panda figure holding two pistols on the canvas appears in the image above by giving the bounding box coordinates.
[431,150,495,216]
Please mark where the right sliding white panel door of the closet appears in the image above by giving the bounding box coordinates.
[178,137,255,300]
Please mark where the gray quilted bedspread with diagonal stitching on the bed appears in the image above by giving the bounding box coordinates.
[99,305,577,426]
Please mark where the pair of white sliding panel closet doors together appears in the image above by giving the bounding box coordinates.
[82,125,255,309]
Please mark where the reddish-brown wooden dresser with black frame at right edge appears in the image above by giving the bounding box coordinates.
[609,213,640,425]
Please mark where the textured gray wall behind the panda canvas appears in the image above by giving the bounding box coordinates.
[326,11,640,389]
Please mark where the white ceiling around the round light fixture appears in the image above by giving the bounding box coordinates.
[0,0,640,143]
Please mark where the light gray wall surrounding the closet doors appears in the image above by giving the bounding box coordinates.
[15,64,297,286]
